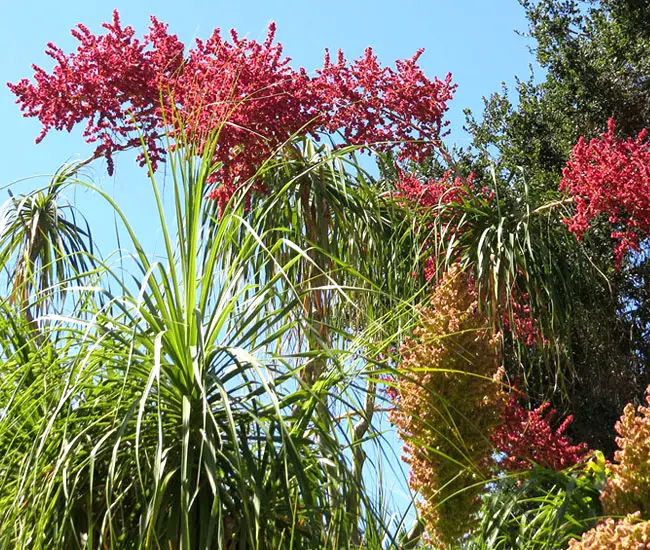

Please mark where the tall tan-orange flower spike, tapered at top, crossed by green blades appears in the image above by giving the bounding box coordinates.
[390,265,506,548]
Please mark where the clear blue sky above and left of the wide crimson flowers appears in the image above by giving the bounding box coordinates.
[0,0,532,528]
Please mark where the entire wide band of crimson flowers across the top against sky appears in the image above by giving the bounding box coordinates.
[9,11,455,209]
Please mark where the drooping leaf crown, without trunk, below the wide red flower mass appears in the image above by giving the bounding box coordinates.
[235,138,421,358]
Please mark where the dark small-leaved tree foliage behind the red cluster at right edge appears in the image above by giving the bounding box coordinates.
[462,0,650,456]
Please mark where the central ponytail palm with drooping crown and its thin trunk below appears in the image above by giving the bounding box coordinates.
[233,138,421,544]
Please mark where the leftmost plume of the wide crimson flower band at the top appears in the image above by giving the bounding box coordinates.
[8,12,183,176]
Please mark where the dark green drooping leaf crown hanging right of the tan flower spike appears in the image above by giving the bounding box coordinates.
[416,170,608,395]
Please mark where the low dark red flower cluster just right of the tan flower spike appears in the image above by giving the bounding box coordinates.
[491,391,589,471]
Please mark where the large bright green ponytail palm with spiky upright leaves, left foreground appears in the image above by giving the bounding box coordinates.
[0,132,420,549]
